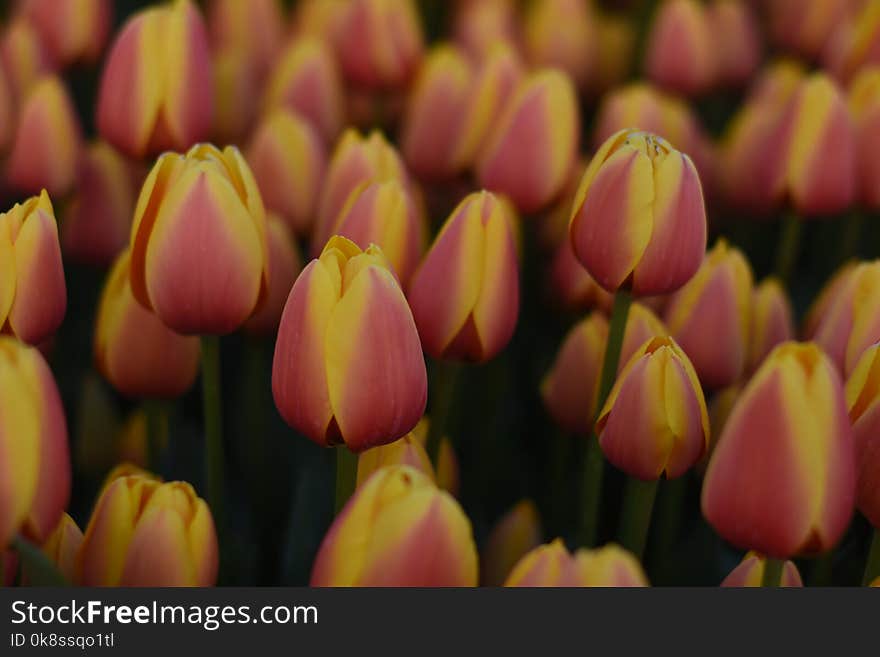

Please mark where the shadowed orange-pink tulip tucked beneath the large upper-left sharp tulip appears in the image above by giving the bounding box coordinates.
[94,249,199,399]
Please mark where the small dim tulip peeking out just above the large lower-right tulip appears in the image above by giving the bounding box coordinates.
[747,277,795,372]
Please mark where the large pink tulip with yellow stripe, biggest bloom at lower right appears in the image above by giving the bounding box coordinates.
[702,342,856,559]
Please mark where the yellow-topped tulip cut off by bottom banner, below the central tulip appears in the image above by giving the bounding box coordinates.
[311,465,477,586]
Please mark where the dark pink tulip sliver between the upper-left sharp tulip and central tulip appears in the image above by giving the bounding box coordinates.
[244,213,302,336]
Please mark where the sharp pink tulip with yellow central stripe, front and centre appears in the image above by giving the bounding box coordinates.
[272,236,427,452]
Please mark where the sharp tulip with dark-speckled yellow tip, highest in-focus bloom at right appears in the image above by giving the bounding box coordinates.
[570,130,706,296]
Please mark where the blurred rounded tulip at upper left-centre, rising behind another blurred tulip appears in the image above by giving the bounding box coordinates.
[264,37,344,143]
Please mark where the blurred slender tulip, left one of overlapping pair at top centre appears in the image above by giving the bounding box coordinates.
[400,45,473,180]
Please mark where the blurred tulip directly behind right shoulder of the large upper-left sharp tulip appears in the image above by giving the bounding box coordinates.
[245,109,327,234]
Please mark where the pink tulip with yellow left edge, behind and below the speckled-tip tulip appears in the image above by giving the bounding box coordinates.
[664,239,753,388]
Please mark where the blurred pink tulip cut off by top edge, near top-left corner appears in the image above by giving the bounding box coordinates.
[21,0,113,67]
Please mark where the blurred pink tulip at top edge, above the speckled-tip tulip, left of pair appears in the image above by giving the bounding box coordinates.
[645,0,720,96]
